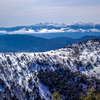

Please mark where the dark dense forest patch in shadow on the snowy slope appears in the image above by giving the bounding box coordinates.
[38,68,100,100]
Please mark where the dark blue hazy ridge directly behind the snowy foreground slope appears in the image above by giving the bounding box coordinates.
[0,34,100,52]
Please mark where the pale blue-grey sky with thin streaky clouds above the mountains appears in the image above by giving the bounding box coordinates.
[0,0,100,27]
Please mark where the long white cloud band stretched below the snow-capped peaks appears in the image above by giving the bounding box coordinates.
[0,28,100,34]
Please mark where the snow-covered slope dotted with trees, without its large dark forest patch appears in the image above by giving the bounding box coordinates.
[0,39,100,100]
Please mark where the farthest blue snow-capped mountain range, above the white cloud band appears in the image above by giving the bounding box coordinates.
[0,22,100,32]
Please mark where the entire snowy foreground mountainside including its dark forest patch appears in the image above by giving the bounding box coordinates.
[0,38,100,100]
